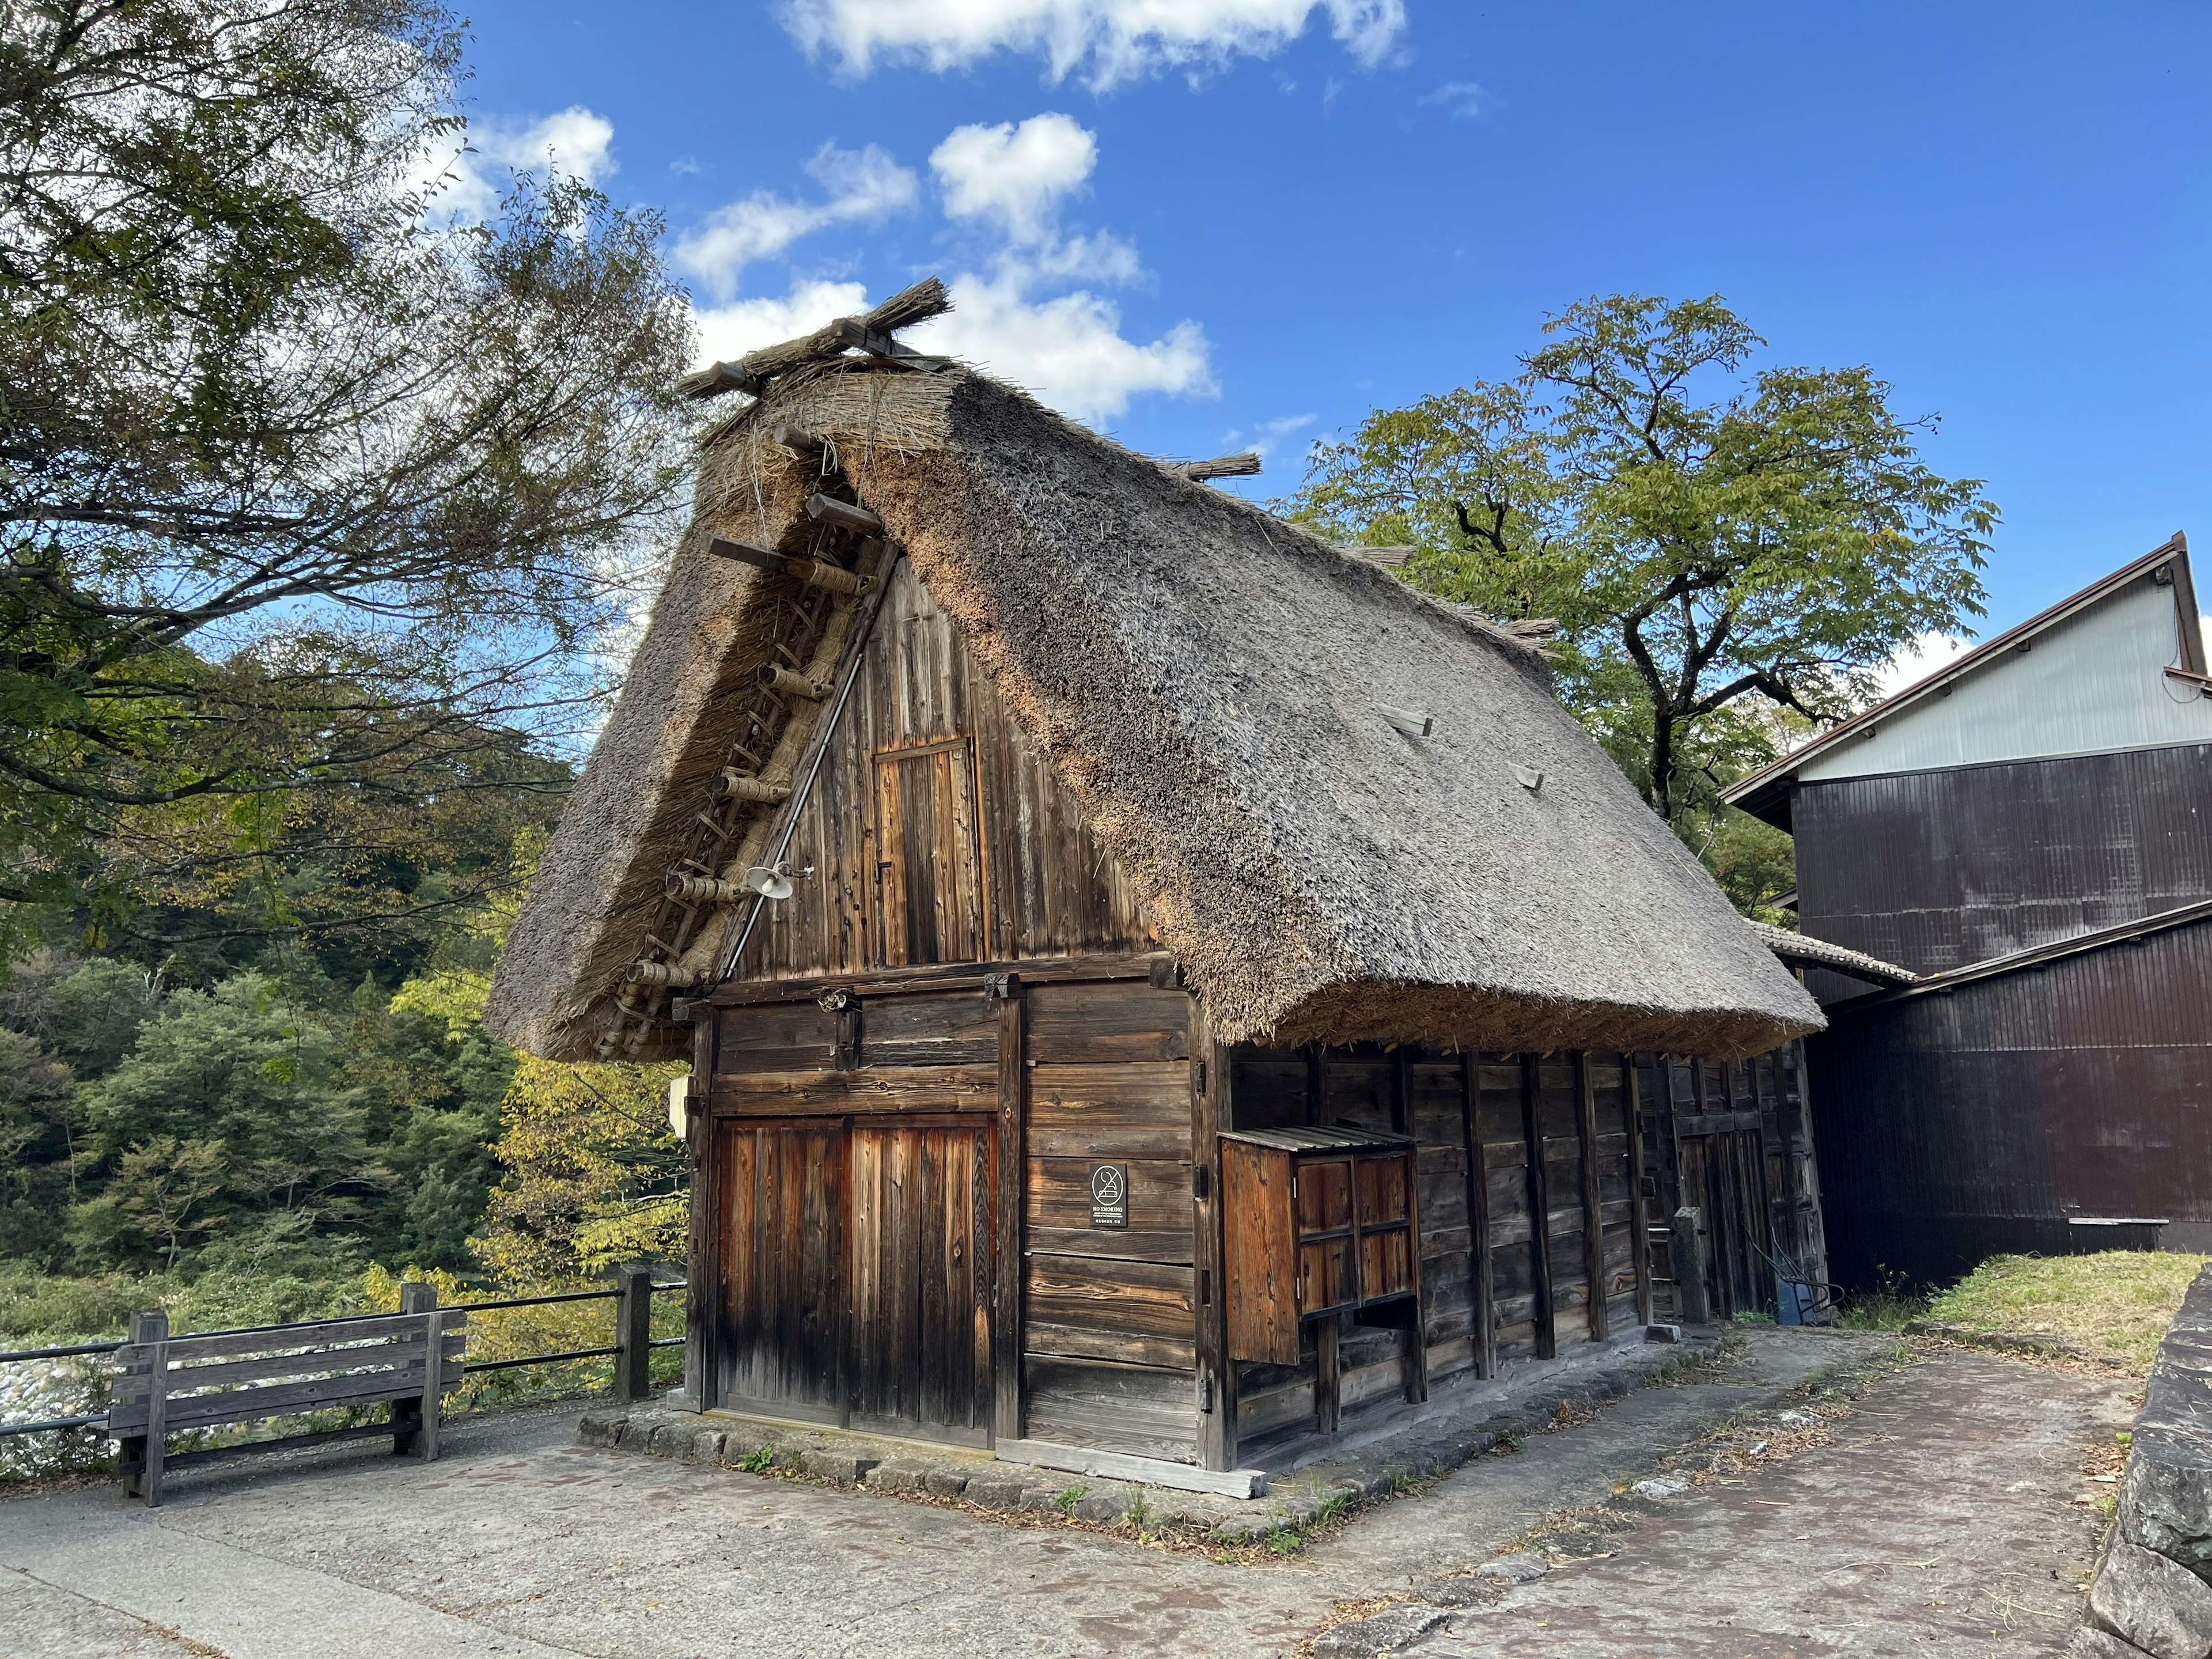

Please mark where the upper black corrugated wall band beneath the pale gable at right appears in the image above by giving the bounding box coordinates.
[1794,743,2212,982]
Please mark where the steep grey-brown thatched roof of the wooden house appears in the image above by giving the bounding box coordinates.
[491,334,1820,1058]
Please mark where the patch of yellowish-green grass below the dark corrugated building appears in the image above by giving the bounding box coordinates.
[1927,1250,2212,1376]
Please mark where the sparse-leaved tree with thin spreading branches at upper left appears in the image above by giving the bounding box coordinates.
[0,0,690,947]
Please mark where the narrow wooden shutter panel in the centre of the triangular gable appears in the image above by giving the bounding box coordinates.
[876,737,988,967]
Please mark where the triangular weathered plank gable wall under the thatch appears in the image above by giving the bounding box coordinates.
[739,560,1154,980]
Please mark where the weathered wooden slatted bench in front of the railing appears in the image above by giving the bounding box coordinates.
[108,1285,467,1509]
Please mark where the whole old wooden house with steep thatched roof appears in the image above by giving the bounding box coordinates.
[491,285,1820,1491]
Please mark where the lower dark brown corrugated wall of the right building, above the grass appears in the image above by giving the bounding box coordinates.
[1805,920,2212,1285]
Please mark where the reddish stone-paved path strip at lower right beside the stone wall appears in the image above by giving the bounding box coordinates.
[1389,1354,2133,1659]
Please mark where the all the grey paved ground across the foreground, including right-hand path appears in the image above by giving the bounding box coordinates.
[0,1332,2128,1659]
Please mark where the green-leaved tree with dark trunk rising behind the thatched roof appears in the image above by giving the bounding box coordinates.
[1290,294,1998,831]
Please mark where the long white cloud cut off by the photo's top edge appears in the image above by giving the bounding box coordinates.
[781,0,1404,90]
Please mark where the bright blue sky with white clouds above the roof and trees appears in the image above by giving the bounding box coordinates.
[444,0,2212,637]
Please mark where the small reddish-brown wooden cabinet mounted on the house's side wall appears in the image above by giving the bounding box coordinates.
[1221,1128,1420,1365]
